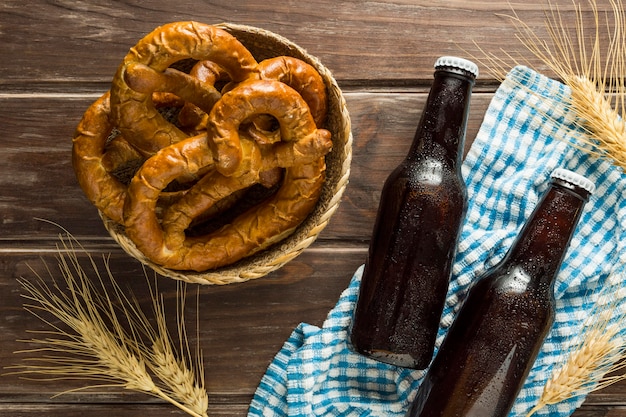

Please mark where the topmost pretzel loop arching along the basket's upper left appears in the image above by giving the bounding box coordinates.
[111,22,258,156]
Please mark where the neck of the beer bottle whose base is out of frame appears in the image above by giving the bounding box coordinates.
[503,181,589,293]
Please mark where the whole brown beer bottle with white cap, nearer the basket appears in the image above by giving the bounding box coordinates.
[351,57,478,369]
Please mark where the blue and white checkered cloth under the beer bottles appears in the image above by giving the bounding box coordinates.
[248,67,626,417]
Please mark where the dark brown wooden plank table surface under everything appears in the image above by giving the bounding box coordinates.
[0,0,626,417]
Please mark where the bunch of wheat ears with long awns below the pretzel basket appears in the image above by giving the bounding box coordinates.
[9,234,208,417]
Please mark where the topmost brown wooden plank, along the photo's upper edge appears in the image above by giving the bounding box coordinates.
[0,0,610,86]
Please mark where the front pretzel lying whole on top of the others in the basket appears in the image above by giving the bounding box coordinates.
[125,80,332,271]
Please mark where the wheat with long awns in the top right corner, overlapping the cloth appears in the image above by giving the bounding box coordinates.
[477,0,626,171]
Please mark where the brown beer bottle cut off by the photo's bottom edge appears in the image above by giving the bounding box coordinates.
[407,169,594,417]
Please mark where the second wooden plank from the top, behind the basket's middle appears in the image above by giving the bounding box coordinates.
[0,92,491,240]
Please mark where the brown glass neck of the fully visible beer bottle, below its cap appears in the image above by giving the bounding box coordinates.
[407,70,474,165]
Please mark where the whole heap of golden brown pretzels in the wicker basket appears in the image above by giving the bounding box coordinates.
[73,22,332,272]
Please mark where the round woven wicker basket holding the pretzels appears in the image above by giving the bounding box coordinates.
[101,23,352,285]
